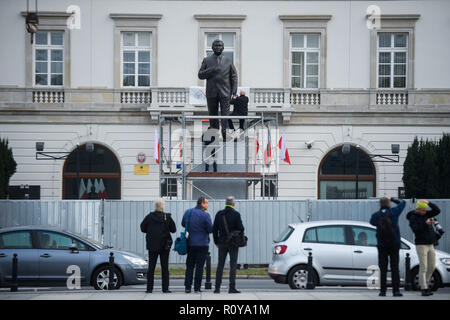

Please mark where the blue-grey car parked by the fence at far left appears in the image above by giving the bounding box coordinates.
[0,226,148,290]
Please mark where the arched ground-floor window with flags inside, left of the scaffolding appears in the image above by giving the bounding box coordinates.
[63,144,120,199]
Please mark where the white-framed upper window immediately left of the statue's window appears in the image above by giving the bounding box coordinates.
[121,32,152,88]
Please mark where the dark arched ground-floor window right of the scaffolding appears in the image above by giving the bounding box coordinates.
[318,146,376,199]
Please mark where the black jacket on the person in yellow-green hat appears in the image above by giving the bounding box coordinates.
[406,202,441,245]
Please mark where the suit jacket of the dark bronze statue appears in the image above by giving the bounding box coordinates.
[198,54,238,98]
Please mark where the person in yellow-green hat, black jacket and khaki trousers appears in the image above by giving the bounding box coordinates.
[406,200,441,296]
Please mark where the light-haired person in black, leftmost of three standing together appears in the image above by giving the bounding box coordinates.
[141,198,177,293]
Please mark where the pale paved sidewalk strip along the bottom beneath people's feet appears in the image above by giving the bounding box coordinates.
[0,288,450,301]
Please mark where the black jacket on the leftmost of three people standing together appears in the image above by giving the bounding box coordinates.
[141,211,177,252]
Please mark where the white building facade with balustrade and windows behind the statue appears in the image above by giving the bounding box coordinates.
[0,0,450,200]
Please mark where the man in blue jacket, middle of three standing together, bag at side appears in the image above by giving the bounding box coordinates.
[181,197,212,293]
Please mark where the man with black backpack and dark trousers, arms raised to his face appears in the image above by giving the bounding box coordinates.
[370,197,406,297]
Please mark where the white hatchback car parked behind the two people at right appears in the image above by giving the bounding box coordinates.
[268,221,450,290]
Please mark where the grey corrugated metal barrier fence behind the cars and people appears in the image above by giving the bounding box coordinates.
[0,199,450,264]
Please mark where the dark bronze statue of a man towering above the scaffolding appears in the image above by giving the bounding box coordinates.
[198,39,238,140]
